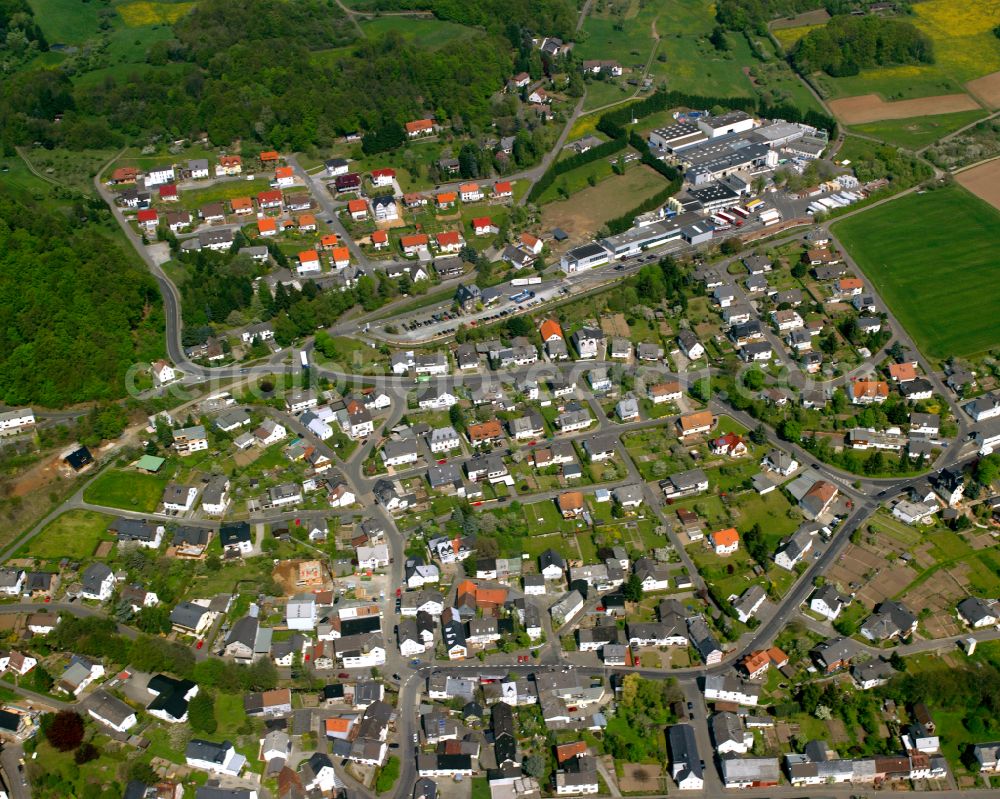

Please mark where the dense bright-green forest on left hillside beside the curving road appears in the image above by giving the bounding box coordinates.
[0,192,163,408]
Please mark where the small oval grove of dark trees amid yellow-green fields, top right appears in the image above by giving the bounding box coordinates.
[791,15,934,77]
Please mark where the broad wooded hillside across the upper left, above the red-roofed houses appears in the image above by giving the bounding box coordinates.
[0,0,575,155]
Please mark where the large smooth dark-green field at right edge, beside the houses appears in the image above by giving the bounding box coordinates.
[833,186,1000,359]
